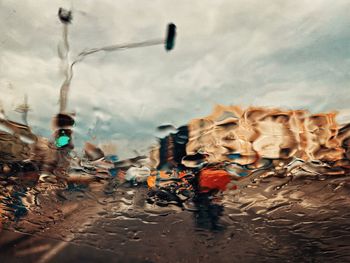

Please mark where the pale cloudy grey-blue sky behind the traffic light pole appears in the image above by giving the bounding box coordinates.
[0,0,350,156]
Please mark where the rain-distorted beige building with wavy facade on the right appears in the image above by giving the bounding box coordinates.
[186,105,350,164]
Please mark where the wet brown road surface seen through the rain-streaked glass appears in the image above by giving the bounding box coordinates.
[0,175,350,262]
